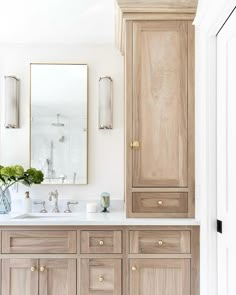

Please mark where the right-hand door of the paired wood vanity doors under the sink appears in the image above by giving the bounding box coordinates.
[39,258,76,295]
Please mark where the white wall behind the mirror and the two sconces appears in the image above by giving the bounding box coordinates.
[0,44,124,199]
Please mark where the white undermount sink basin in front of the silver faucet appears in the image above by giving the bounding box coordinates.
[12,213,78,219]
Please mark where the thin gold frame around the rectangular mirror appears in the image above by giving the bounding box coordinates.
[29,62,89,185]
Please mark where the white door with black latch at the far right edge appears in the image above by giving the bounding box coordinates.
[217,11,236,295]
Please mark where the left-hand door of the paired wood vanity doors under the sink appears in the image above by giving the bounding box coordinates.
[1,258,38,295]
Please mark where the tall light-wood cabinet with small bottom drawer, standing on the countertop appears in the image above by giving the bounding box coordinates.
[117,0,196,217]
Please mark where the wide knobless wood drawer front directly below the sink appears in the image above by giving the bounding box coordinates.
[2,230,76,254]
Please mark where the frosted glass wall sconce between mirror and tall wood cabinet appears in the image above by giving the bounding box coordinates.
[99,76,113,129]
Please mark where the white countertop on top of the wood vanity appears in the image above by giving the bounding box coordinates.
[0,211,200,226]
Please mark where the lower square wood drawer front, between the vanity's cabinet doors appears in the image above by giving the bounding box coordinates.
[80,258,122,295]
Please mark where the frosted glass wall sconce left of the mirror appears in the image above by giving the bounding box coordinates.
[4,76,19,128]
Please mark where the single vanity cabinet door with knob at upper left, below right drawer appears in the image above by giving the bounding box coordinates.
[130,259,191,295]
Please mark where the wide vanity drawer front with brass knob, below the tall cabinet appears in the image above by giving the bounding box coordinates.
[129,230,190,254]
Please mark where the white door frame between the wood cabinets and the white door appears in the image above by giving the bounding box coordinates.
[194,0,236,295]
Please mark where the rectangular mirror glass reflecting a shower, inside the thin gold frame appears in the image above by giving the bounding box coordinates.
[31,64,87,184]
